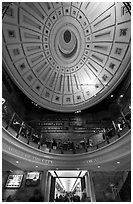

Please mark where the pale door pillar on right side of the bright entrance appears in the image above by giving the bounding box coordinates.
[85,171,96,202]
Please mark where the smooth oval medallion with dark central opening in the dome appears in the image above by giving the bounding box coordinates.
[49,16,85,67]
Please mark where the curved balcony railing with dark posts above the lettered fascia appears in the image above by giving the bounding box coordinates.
[2,102,130,154]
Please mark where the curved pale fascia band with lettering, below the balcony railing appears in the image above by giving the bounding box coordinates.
[2,128,131,168]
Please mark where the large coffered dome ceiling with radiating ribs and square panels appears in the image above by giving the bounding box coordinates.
[3,2,131,112]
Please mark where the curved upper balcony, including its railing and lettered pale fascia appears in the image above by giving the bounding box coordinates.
[2,97,131,169]
